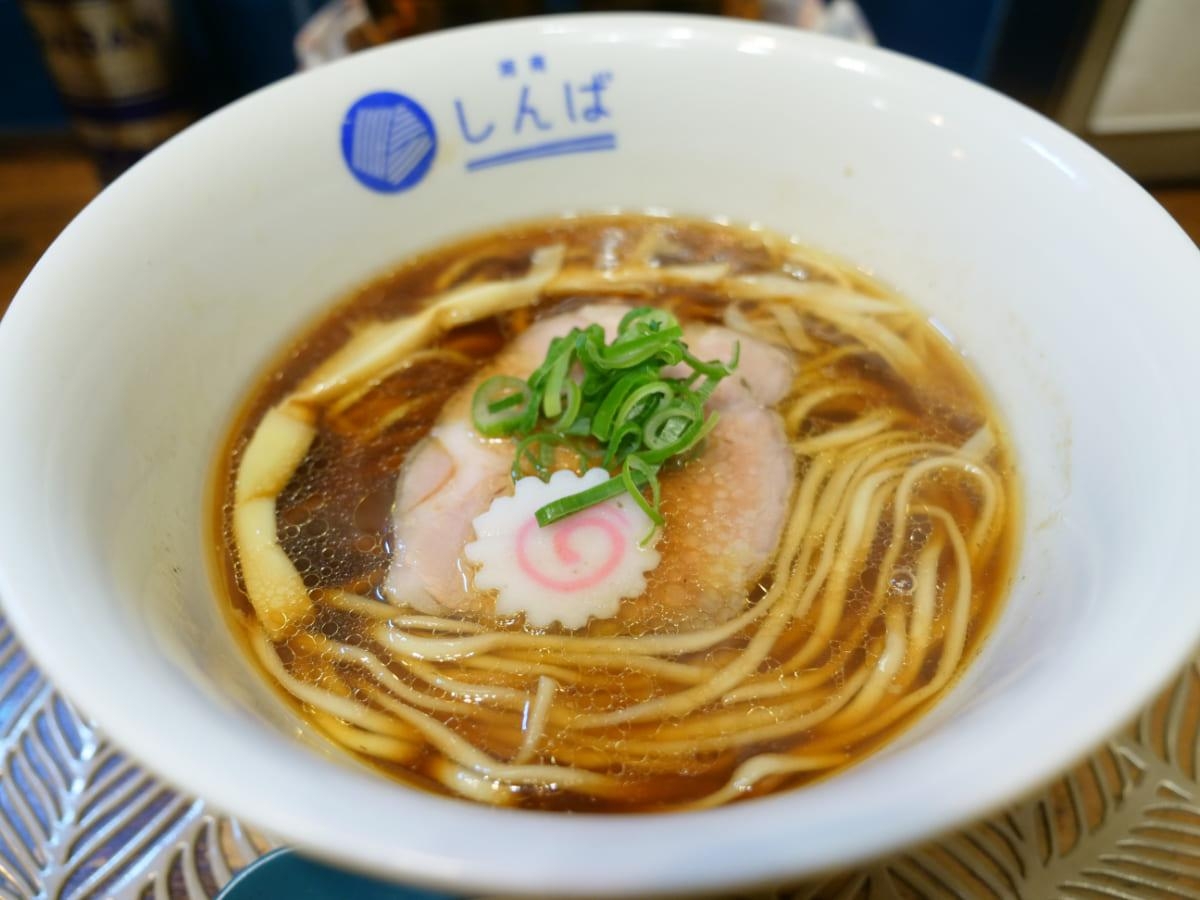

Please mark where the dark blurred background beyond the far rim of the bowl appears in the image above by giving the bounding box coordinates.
[0,0,1200,312]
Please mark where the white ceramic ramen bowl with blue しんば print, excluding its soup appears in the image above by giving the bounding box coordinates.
[0,17,1200,895]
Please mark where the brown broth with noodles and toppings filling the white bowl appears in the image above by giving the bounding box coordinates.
[209,215,1019,811]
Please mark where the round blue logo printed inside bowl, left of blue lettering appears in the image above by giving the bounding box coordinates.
[342,91,438,193]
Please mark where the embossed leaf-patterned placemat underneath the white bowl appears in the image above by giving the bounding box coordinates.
[0,617,1200,900]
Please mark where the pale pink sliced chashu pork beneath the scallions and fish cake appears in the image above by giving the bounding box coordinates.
[385,305,794,631]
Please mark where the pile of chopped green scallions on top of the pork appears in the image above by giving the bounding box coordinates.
[472,306,740,527]
